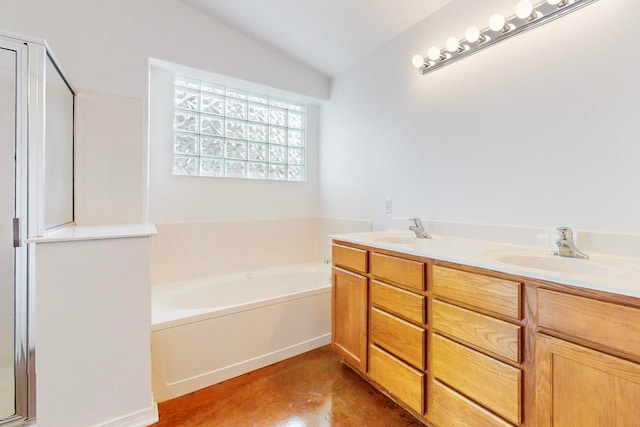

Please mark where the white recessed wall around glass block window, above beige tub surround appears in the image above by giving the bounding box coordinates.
[149,66,319,224]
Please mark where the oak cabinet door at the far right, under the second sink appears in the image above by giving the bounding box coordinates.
[536,334,640,427]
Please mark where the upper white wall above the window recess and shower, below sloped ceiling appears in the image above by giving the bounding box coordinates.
[0,0,329,103]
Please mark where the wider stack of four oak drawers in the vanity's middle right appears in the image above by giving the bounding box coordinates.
[429,266,523,426]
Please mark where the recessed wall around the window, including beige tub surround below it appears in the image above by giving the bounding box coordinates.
[149,61,328,284]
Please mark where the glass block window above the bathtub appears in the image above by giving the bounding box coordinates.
[173,77,307,181]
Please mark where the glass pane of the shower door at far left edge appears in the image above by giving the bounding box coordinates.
[0,48,17,420]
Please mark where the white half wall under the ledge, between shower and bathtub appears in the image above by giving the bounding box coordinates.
[35,237,155,427]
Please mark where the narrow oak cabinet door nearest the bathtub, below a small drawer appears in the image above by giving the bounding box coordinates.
[331,268,367,373]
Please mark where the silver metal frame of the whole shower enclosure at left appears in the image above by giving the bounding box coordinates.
[0,30,76,427]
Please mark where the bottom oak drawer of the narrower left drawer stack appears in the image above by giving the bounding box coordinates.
[369,345,424,414]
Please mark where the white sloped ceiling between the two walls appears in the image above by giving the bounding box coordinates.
[180,0,450,77]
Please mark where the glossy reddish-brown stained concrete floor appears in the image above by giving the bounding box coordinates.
[155,346,423,427]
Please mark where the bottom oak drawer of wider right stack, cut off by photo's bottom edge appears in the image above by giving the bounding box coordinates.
[429,381,512,427]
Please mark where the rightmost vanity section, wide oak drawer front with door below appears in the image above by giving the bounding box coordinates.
[535,289,640,427]
